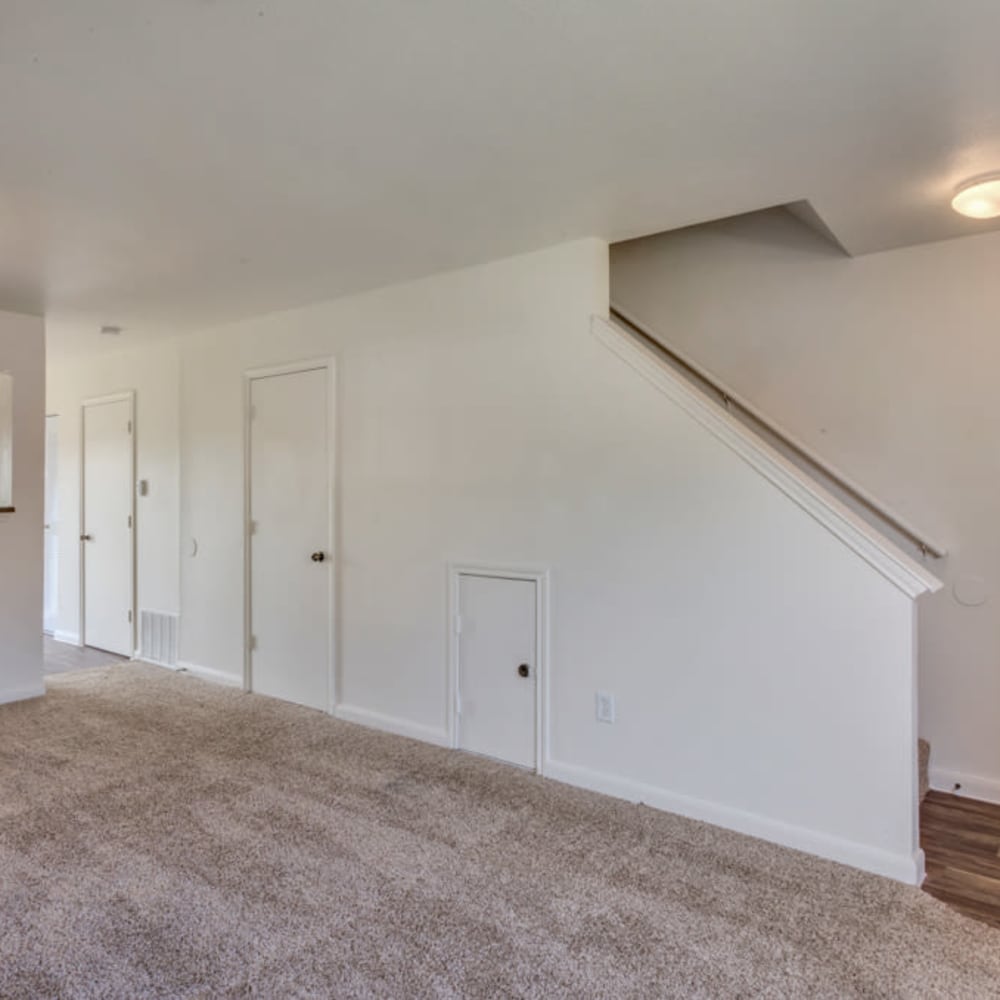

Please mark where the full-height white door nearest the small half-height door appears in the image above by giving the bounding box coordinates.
[248,368,334,711]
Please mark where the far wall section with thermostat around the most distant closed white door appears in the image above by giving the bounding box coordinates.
[46,334,180,642]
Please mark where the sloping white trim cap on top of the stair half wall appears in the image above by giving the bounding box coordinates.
[591,316,942,599]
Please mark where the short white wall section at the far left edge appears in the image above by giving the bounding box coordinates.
[0,313,45,702]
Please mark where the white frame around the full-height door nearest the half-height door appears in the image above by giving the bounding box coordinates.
[243,357,340,715]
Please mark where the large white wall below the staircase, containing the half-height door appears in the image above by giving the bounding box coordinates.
[168,241,918,879]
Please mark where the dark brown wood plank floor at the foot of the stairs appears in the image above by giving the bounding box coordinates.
[920,792,1000,927]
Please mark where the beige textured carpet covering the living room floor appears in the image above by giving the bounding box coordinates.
[0,666,1000,1000]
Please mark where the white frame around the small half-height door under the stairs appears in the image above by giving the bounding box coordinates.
[446,563,549,775]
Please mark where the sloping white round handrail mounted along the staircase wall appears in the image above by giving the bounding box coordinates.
[609,303,948,559]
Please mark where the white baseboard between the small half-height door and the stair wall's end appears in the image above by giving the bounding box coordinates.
[545,760,924,885]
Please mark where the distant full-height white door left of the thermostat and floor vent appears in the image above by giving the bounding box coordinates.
[80,396,133,656]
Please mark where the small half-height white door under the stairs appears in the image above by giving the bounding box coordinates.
[458,573,538,769]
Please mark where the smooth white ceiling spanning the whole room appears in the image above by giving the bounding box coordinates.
[0,0,1000,349]
